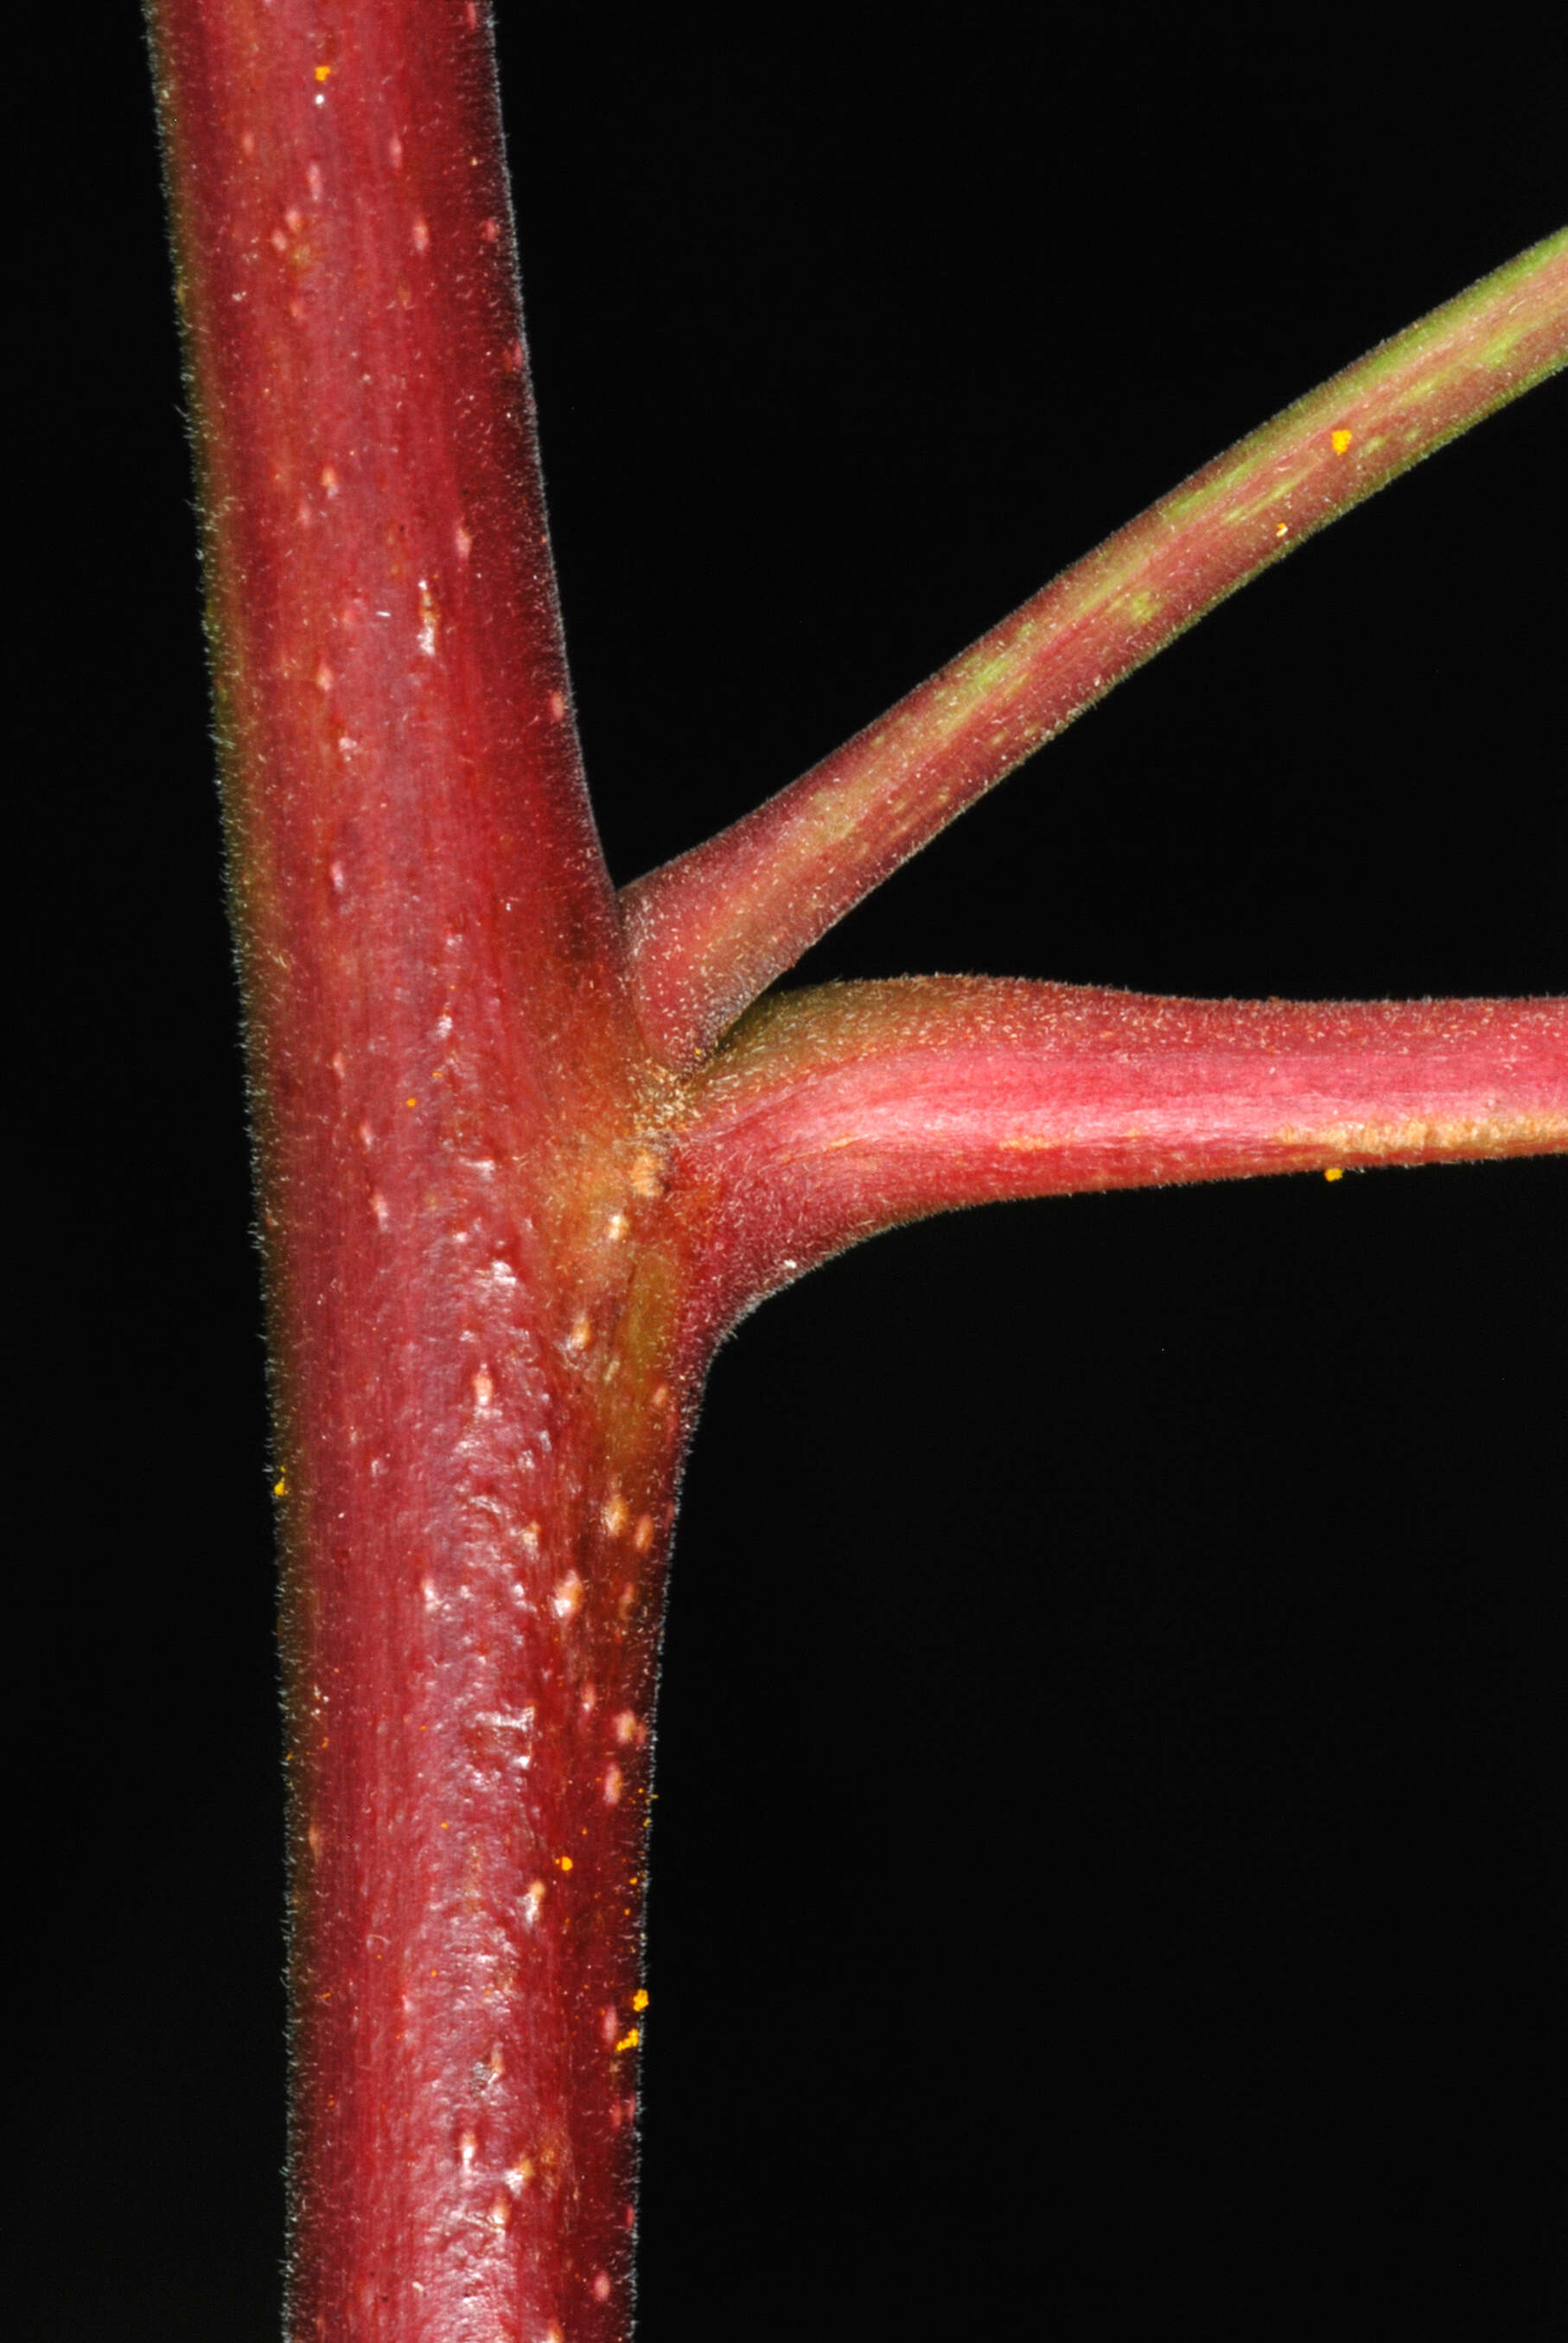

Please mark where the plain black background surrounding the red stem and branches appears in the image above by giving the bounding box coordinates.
[4,0,1568,2343]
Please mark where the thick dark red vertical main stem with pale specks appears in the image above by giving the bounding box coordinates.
[152,0,689,2343]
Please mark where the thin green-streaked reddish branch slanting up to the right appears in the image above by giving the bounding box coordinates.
[621,230,1568,1066]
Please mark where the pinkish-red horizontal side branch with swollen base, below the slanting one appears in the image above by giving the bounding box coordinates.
[670,977,1568,1326]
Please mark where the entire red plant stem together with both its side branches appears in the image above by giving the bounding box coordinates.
[150,0,1568,2343]
